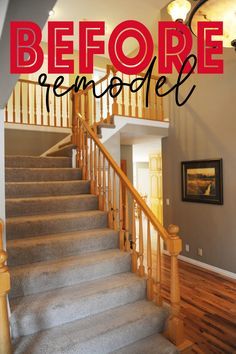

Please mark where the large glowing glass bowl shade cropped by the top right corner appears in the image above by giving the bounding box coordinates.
[189,0,236,48]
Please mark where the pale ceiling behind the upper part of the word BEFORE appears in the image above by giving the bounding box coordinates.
[43,0,170,56]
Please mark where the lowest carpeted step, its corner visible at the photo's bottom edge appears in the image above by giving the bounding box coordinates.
[112,333,179,354]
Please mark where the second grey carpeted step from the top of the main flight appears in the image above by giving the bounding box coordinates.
[5,168,82,182]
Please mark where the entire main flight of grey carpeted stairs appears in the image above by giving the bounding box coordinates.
[6,156,177,354]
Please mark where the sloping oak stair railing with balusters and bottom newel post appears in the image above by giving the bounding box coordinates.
[76,116,184,346]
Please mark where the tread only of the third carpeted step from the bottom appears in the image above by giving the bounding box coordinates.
[11,273,145,318]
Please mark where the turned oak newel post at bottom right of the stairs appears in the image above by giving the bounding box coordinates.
[168,225,185,346]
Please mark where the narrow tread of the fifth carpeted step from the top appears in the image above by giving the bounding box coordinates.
[7,210,107,224]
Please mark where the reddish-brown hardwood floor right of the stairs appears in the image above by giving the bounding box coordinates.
[162,255,236,354]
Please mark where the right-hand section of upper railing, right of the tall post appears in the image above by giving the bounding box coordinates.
[73,65,164,129]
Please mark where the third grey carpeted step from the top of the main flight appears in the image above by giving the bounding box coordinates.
[6,180,90,198]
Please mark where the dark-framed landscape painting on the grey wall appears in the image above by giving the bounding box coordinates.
[181,159,223,205]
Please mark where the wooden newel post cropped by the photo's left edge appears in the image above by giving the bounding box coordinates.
[0,220,12,354]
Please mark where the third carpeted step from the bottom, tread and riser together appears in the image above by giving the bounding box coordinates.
[11,273,146,337]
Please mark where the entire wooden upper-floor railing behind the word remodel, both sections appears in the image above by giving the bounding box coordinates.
[5,65,164,128]
